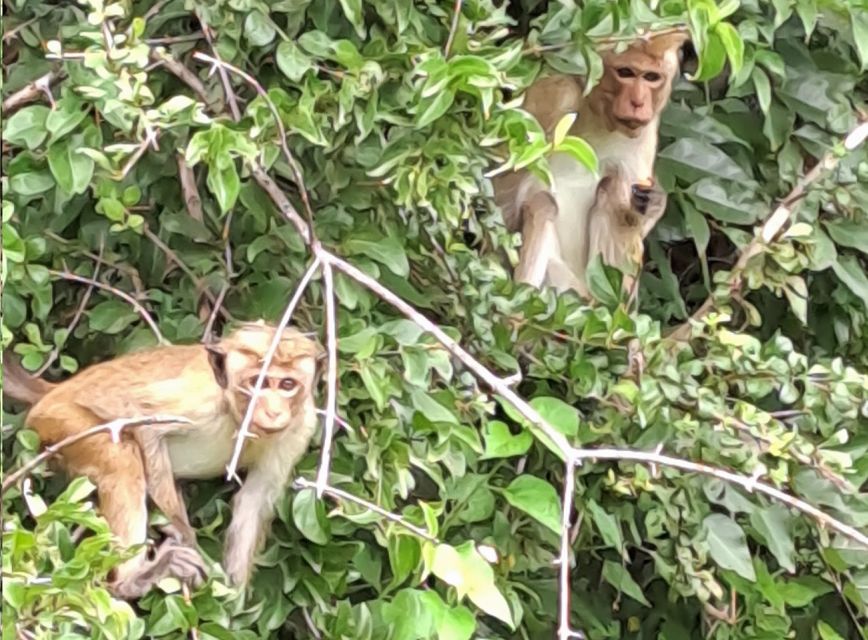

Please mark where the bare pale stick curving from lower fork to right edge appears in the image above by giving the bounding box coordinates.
[572,448,868,548]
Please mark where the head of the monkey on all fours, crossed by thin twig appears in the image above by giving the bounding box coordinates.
[207,322,322,436]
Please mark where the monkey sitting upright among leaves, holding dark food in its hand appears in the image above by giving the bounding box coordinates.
[493,32,687,297]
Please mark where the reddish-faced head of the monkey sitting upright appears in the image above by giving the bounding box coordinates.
[589,33,687,138]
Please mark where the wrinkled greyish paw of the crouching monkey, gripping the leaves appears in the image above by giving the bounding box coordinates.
[111,538,207,600]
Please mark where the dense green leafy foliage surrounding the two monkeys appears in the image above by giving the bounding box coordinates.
[2,0,868,640]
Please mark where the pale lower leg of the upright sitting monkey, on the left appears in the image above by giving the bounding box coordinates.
[515,191,560,287]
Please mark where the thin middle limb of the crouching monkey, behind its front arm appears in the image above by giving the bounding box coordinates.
[135,427,196,549]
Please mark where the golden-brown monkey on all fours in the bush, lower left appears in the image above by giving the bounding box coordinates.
[4,322,323,600]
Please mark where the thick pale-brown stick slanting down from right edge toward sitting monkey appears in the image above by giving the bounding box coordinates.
[669,122,868,340]
